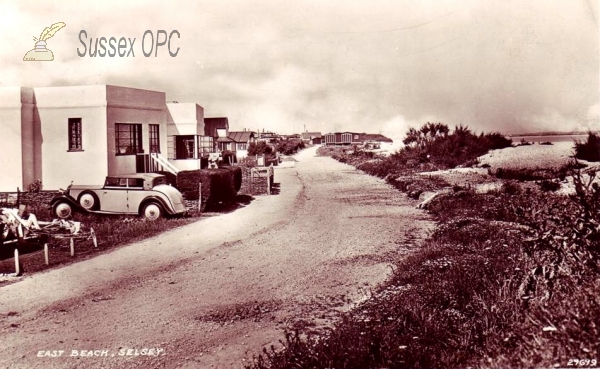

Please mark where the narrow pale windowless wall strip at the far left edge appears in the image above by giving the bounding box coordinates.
[0,87,24,192]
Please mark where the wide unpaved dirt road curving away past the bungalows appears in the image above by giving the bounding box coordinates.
[0,148,431,368]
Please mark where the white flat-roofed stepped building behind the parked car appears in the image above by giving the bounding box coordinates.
[0,85,212,191]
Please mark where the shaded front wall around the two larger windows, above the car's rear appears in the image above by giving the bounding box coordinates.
[105,86,168,175]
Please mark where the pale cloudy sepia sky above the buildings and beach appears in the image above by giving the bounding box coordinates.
[0,0,600,139]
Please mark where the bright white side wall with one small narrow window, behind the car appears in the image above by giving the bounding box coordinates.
[34,86,108,190]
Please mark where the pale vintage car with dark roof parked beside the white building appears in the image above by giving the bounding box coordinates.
[51,173,186,220]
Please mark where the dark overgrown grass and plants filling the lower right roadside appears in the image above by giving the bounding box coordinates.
[251,145,600,369]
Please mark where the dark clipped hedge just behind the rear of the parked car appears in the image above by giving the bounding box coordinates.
[177,168,241,207]
